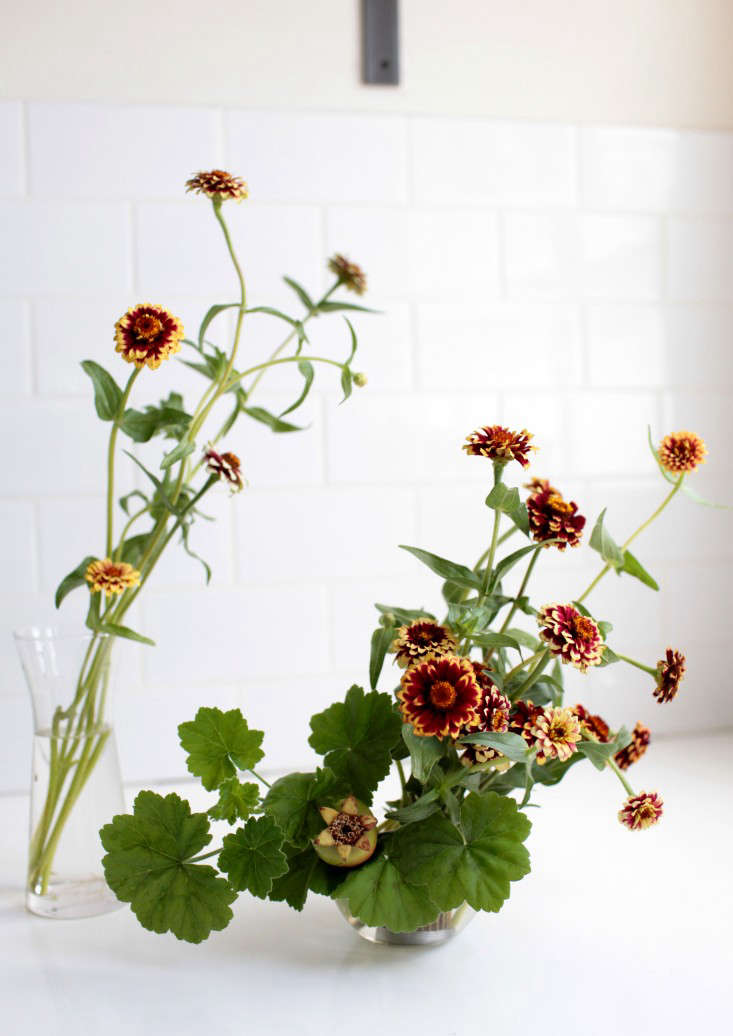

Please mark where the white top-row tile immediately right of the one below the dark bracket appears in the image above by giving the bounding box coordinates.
[411,118,576,206]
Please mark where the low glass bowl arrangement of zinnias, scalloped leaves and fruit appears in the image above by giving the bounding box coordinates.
[100,426,706,943]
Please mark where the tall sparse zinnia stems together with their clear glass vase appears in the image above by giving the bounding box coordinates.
[17,170,367,917]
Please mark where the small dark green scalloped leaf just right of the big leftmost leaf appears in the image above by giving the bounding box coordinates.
[218,816,288,899]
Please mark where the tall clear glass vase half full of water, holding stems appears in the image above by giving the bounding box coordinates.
[14,627,125,918]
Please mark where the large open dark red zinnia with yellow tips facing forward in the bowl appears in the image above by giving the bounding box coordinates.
[398,655,481,738]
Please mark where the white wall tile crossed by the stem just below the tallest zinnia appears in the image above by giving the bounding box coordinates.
[136,198,325,307]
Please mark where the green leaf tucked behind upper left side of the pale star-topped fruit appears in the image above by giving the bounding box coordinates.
[262,770,349,848]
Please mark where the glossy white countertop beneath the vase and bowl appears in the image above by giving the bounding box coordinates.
[0,735,733,1036]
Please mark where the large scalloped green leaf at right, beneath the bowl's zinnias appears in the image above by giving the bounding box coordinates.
[390,792,531,912]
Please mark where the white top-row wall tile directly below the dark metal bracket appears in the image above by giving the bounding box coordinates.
[226,112,407,203]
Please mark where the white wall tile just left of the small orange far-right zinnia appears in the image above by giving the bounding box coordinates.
[569,392,658,474]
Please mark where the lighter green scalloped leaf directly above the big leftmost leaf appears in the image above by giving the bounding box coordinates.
[178,707,265,792]
